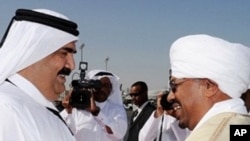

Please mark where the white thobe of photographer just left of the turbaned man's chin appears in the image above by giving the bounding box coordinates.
[139,112,189,141]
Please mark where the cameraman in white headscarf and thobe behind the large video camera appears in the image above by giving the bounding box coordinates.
[61,70,127,141]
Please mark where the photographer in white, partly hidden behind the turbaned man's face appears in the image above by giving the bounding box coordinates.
[139,91,189,141]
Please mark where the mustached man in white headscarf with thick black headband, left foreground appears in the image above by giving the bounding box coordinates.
[0,9,79,141]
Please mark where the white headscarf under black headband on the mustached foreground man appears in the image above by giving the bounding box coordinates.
[0,9,78,84]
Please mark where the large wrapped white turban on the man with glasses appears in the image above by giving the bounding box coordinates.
[170,35,250,98]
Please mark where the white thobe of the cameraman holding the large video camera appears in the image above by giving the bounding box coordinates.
[61,101,127,141]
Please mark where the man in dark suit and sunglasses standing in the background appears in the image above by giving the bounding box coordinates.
[127,81,155,141]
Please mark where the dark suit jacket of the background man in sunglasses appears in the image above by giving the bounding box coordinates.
[127,102,155,141]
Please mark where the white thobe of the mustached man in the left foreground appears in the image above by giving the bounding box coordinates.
[0,74,75,141]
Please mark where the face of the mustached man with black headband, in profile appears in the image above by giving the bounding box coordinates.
[20,42,76,101]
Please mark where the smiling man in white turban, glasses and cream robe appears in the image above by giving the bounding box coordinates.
[168,35,250,141]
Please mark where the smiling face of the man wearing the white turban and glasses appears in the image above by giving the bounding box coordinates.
[167,77,205,130]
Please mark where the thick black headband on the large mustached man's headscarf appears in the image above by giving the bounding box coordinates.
[0,9,79,47]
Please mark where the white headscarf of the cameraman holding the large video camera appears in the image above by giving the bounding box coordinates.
[86,70,123,105]
